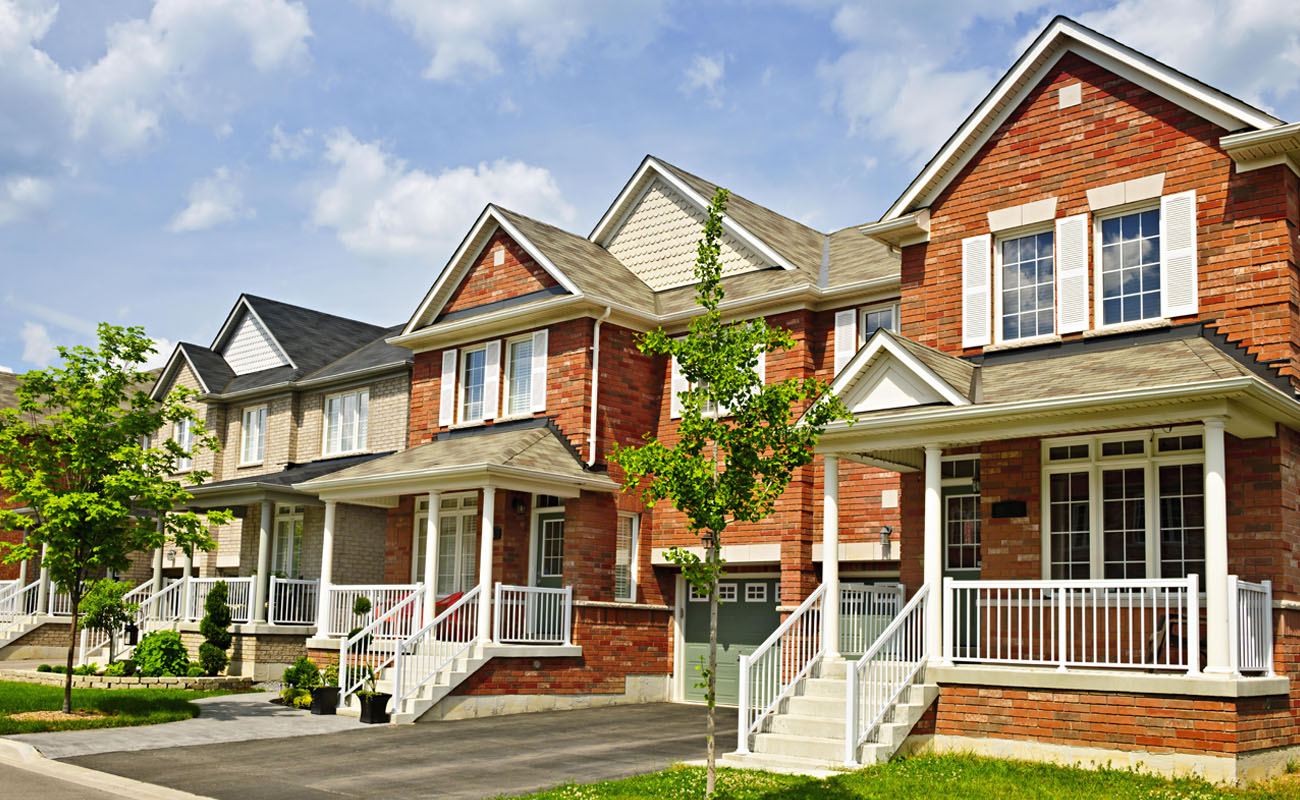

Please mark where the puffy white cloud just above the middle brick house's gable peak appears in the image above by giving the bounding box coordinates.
[312,129,576,261]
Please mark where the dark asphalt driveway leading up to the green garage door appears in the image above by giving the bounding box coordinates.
[68,704,736,800]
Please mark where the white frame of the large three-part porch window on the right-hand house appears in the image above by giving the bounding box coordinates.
[1039,425,1205,580]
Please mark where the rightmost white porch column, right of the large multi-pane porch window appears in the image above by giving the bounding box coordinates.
[1205,419,1232,674]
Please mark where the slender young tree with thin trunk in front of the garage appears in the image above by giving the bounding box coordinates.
[614,189,849,797]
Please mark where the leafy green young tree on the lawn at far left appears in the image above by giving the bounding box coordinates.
[0,323,231,712]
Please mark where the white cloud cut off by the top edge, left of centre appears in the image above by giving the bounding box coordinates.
[387,0,667,81]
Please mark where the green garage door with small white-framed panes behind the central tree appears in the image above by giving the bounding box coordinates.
[684,578,781,705]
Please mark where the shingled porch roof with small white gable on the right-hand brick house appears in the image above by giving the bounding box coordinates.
[818,324,1300,471]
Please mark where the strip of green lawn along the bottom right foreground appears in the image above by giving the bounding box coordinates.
[504,756,1300,800]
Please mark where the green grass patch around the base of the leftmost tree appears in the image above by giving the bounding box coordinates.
[0,680,244,735]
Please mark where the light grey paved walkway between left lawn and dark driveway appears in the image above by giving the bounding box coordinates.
[5,692,366,758]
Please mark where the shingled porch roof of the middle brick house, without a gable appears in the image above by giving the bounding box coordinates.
[294,419,619,506]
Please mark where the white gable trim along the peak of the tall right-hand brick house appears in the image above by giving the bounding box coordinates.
[880,17,1282,221]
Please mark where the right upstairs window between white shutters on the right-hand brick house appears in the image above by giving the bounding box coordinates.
[1100,208,1161,325]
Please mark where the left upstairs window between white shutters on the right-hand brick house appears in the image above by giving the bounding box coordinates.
[996,230,1056,341]
